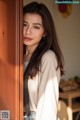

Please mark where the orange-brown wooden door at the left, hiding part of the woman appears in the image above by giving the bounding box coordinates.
[0,0,23,120]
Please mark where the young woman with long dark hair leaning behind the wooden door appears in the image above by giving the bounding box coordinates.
[23,2,64,120]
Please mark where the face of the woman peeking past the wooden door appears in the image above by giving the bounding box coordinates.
[23,13,44,47]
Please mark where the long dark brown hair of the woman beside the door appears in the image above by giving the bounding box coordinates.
[23,2,64,78]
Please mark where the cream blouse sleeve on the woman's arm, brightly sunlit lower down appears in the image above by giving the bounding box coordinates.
[36,51,60,120]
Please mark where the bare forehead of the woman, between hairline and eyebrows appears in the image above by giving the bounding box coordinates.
[24,13,42,24]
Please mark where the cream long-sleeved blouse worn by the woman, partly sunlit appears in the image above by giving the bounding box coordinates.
[24,50,60,120]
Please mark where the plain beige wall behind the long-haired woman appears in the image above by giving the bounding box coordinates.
[24,0,80,79]
